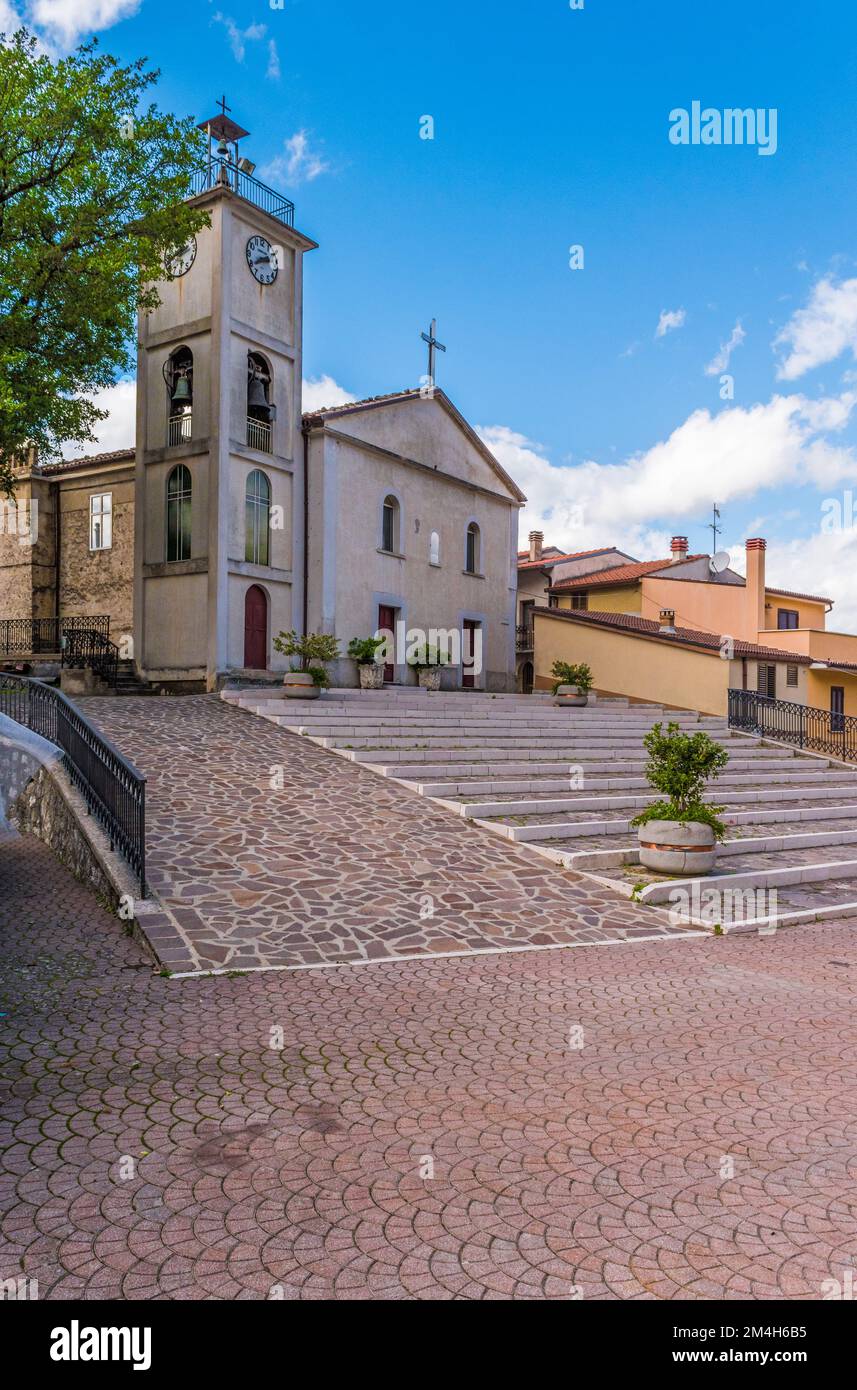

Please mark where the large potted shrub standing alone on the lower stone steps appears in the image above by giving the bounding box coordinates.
[631,723,729,874]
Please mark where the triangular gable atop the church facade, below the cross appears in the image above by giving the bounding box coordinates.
[304,391,525,503]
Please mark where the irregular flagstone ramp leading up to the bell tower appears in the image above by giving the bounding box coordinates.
[79,695,697,972]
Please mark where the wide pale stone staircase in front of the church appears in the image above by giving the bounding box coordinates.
[224,689,857,930]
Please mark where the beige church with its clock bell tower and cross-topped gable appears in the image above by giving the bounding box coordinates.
[0,110,525,692]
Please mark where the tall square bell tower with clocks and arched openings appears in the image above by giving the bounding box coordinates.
[135,99,317,689]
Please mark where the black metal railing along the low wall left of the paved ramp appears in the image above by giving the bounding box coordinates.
[0,673,146,898]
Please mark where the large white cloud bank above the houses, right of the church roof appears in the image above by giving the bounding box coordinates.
[479,392,857,556]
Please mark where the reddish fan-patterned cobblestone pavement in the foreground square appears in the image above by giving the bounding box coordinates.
[0,840,857,1300]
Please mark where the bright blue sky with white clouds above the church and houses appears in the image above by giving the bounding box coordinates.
[13,0,857,627]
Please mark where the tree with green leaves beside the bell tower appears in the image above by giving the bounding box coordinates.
[0,29,208,492]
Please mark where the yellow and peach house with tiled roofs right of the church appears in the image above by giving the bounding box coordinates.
[533,535,857,717]
